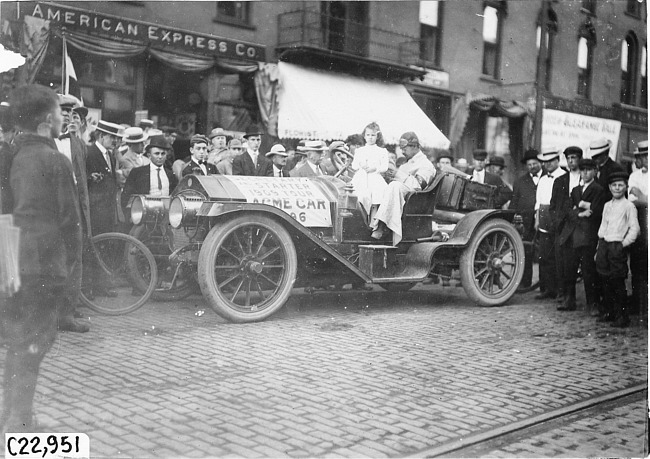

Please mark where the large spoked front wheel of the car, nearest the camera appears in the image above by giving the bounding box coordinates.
[198,215,298,323]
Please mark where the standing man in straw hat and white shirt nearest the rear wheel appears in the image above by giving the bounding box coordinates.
[535,147,566,300]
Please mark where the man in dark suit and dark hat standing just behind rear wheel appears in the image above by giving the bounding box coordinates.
[510,149,542,287]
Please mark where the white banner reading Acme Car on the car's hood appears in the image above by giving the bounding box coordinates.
[228,175,332,227]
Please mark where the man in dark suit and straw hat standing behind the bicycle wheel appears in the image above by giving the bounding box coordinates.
[86,120,122,235]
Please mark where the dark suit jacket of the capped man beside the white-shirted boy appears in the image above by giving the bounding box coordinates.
[556,181,607,247]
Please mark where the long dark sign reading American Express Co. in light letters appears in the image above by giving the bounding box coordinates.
[30,3,265,61]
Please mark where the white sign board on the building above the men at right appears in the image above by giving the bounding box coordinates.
[542,108,621,160]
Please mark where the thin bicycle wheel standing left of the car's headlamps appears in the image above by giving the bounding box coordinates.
[80,233,158,316]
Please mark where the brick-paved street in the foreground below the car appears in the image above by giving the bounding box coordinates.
[0,286,647,458]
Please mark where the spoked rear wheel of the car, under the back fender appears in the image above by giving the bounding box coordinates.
[460,219,524,306]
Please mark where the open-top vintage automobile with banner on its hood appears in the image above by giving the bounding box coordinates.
[131,171,524,322]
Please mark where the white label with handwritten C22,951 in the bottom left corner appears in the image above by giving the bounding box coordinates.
[5,433,90,459]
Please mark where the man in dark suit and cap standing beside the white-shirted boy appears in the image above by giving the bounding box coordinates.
[556,159,606,312]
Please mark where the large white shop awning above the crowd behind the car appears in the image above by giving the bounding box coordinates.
[278,62,449,149]
